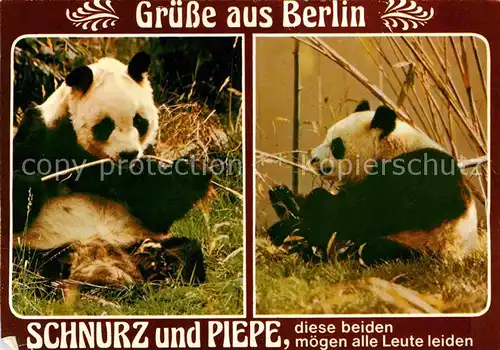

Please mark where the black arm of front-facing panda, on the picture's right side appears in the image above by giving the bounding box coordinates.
[113,159,211,233]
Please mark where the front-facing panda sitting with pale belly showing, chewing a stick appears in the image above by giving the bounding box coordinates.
[12,53,211,285]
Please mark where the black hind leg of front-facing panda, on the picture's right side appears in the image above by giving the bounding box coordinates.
[132,237,206,284]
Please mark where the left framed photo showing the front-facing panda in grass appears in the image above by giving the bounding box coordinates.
[10,36,245,317]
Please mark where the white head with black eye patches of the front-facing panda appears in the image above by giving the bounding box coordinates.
[61,52,158,161]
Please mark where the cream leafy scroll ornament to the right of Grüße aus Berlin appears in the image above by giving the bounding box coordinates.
[380,0,434,32]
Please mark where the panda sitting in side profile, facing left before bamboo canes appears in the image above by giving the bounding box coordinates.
[268,101,478,264]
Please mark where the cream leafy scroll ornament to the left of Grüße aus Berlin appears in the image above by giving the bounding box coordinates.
[66,0,119,32]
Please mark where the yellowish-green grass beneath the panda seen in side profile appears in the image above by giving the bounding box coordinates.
[256,232,488,314]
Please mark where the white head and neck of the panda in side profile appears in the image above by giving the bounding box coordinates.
[309,101,444,183]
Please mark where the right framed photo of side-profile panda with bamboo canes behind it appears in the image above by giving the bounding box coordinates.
[254,34,490,316]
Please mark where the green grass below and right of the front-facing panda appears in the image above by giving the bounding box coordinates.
[13,178,243,316]
